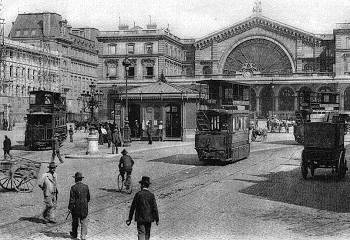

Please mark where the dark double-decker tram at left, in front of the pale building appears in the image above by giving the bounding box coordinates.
[24,91,67,150]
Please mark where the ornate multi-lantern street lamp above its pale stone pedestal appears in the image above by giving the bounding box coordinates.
[80,82,103,123]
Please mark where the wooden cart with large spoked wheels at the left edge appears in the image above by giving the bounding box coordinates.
[0,157,41,192]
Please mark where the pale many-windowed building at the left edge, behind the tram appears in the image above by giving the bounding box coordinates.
[0,39,62,128]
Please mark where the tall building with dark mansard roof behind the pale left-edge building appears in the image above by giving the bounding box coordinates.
[9,12,99,117]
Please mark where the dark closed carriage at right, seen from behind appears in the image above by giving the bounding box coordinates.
[301,122,348,179]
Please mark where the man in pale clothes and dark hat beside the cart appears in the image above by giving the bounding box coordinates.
[38,162,58,223]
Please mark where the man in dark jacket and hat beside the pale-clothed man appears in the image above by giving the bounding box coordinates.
[68,172,90,240]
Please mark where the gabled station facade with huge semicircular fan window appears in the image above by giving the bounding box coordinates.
[194,12,350,118]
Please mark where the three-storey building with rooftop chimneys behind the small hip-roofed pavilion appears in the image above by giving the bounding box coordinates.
[97,24,194,141]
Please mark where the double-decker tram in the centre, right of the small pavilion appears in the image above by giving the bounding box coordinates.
[195,80,250,163]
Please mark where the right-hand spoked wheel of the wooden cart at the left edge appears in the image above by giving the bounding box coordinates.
[13,168,36,193]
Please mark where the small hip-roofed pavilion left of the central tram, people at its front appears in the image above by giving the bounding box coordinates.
[120,81,199,141]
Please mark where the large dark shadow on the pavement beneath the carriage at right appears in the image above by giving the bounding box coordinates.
[235,168,350,213]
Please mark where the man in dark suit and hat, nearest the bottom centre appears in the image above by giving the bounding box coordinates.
[126,176,159,240]
